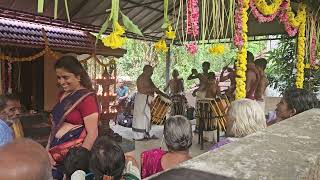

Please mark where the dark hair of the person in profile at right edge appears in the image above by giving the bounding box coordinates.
[283,88,319,114]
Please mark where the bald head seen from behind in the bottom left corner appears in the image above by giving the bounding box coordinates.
[0,138,52,180]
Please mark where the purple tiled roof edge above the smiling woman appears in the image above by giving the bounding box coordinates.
[0,18,125,57]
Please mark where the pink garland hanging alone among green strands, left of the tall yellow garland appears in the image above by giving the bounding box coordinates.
[186,0,199,37]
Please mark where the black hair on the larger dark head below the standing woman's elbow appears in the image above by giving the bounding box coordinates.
[89,136,125,180]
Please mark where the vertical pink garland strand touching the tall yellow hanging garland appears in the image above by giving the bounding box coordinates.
[233,0,243,48]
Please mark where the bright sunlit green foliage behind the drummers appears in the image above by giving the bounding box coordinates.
[117,39,266,89]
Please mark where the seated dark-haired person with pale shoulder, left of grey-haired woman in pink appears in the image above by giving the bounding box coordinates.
[89,136,140,180]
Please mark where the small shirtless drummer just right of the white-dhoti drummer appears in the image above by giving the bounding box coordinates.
[164,69,184,96]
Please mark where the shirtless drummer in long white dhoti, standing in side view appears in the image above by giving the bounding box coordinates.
[132,65,166,140]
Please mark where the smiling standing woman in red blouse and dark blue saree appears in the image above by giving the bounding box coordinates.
[47,56,99,179]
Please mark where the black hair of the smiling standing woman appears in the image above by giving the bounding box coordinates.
[54,56,93,91]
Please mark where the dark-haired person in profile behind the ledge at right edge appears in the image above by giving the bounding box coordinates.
[267,88,319,126]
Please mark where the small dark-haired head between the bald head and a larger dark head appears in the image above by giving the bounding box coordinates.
[64,146,90,180]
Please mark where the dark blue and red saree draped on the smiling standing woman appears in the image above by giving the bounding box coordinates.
[49,89,93,163]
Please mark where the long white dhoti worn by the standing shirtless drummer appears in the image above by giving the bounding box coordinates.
[132,93,153,140]
